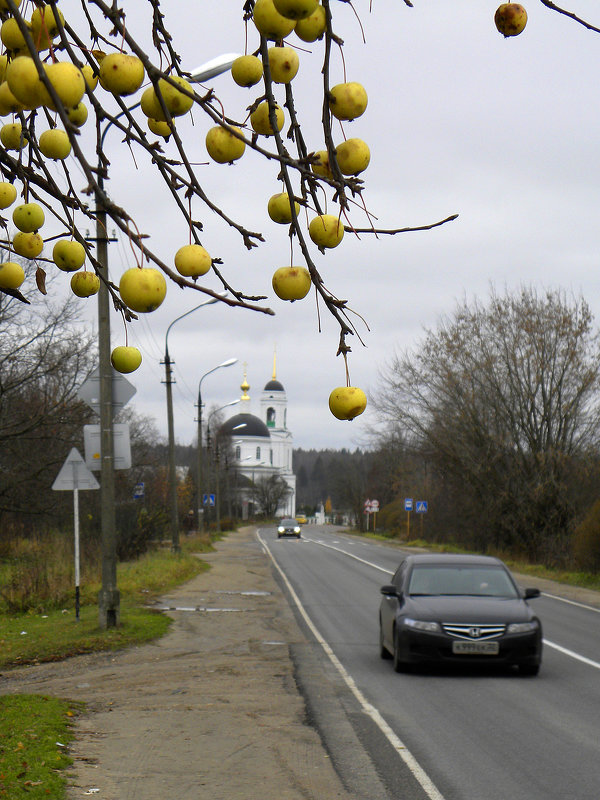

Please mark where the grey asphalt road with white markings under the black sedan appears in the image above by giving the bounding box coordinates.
[259,526,600,800]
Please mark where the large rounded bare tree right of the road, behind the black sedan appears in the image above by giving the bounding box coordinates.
[375,288,600,558]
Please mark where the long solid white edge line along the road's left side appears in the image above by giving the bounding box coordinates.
[256,532,444,800]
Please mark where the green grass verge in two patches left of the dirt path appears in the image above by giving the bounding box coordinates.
[0,537,218,800]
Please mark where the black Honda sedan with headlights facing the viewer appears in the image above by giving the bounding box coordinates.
[379,554,542,675]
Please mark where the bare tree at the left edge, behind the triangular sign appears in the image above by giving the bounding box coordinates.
[0,284,95,517]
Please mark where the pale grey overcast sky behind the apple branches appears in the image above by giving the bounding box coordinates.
[34,0,600,449]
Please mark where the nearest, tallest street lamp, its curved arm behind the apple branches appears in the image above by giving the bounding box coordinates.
[94,53,236,628]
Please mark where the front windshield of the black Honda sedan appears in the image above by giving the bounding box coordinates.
[408,564,518,598]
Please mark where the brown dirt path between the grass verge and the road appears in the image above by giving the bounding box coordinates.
[0,529,354,800]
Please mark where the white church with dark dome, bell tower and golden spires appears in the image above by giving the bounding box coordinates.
[221,357,296,518]
